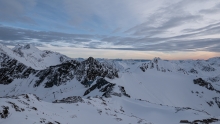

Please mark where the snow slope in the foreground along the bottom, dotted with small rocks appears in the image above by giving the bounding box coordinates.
[0,94,217,124]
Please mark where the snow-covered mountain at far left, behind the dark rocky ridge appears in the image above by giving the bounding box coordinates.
[0,44,70,70]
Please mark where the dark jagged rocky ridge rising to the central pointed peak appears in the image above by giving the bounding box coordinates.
[35,57,118,88]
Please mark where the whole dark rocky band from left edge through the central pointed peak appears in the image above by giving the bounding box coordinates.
[0,53,118,88]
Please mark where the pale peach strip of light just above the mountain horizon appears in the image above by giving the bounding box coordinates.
[38,46,220,60]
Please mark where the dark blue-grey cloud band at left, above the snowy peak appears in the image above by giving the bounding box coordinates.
[0,26,97,46]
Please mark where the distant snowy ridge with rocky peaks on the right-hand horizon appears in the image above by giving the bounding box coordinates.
[139,57,220,78]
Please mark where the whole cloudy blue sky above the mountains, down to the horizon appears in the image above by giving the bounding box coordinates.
[0,0,220,60]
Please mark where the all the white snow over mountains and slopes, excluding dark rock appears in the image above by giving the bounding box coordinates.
[0,44,220,124]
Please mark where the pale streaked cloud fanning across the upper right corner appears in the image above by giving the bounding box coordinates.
[125,0,220,37]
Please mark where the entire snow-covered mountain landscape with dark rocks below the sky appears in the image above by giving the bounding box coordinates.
[0,45,220,124]
